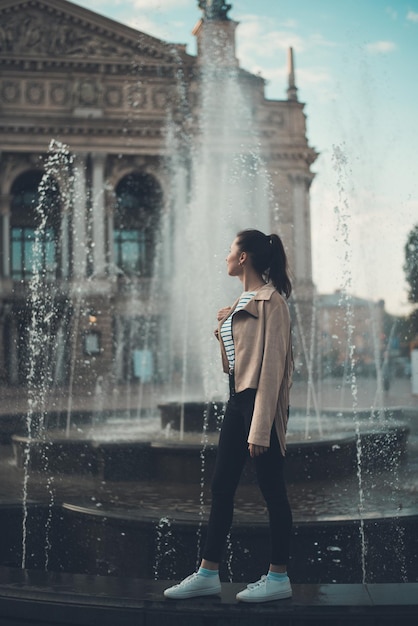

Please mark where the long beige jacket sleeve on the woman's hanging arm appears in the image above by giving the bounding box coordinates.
[248,298,290,447]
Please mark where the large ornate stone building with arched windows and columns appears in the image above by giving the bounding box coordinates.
[0,0,316,387]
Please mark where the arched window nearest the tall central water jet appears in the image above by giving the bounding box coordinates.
[114,173,162,277]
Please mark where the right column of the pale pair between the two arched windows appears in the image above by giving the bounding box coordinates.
[91,153,106,276]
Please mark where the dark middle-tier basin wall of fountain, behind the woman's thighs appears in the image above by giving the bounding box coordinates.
[12,424,409,484]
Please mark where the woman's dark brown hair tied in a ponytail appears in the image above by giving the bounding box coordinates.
[237,230,292,298]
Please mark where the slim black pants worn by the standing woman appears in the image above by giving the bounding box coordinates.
[203,389,292,565]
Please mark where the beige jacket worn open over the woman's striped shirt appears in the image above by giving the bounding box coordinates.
[216,283,293,455]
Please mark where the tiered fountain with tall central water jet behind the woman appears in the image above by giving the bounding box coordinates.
[2,3,418,616]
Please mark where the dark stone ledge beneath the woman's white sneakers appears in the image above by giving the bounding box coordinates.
[0,567,418,626]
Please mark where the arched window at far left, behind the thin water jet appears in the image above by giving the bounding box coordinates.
[10,171,60,280]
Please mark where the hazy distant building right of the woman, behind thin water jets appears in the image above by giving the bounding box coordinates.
[315,291,386,375]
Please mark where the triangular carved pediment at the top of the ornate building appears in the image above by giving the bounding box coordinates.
[0,0,188,63]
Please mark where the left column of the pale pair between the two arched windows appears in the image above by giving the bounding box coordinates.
[72,154,87,280]
